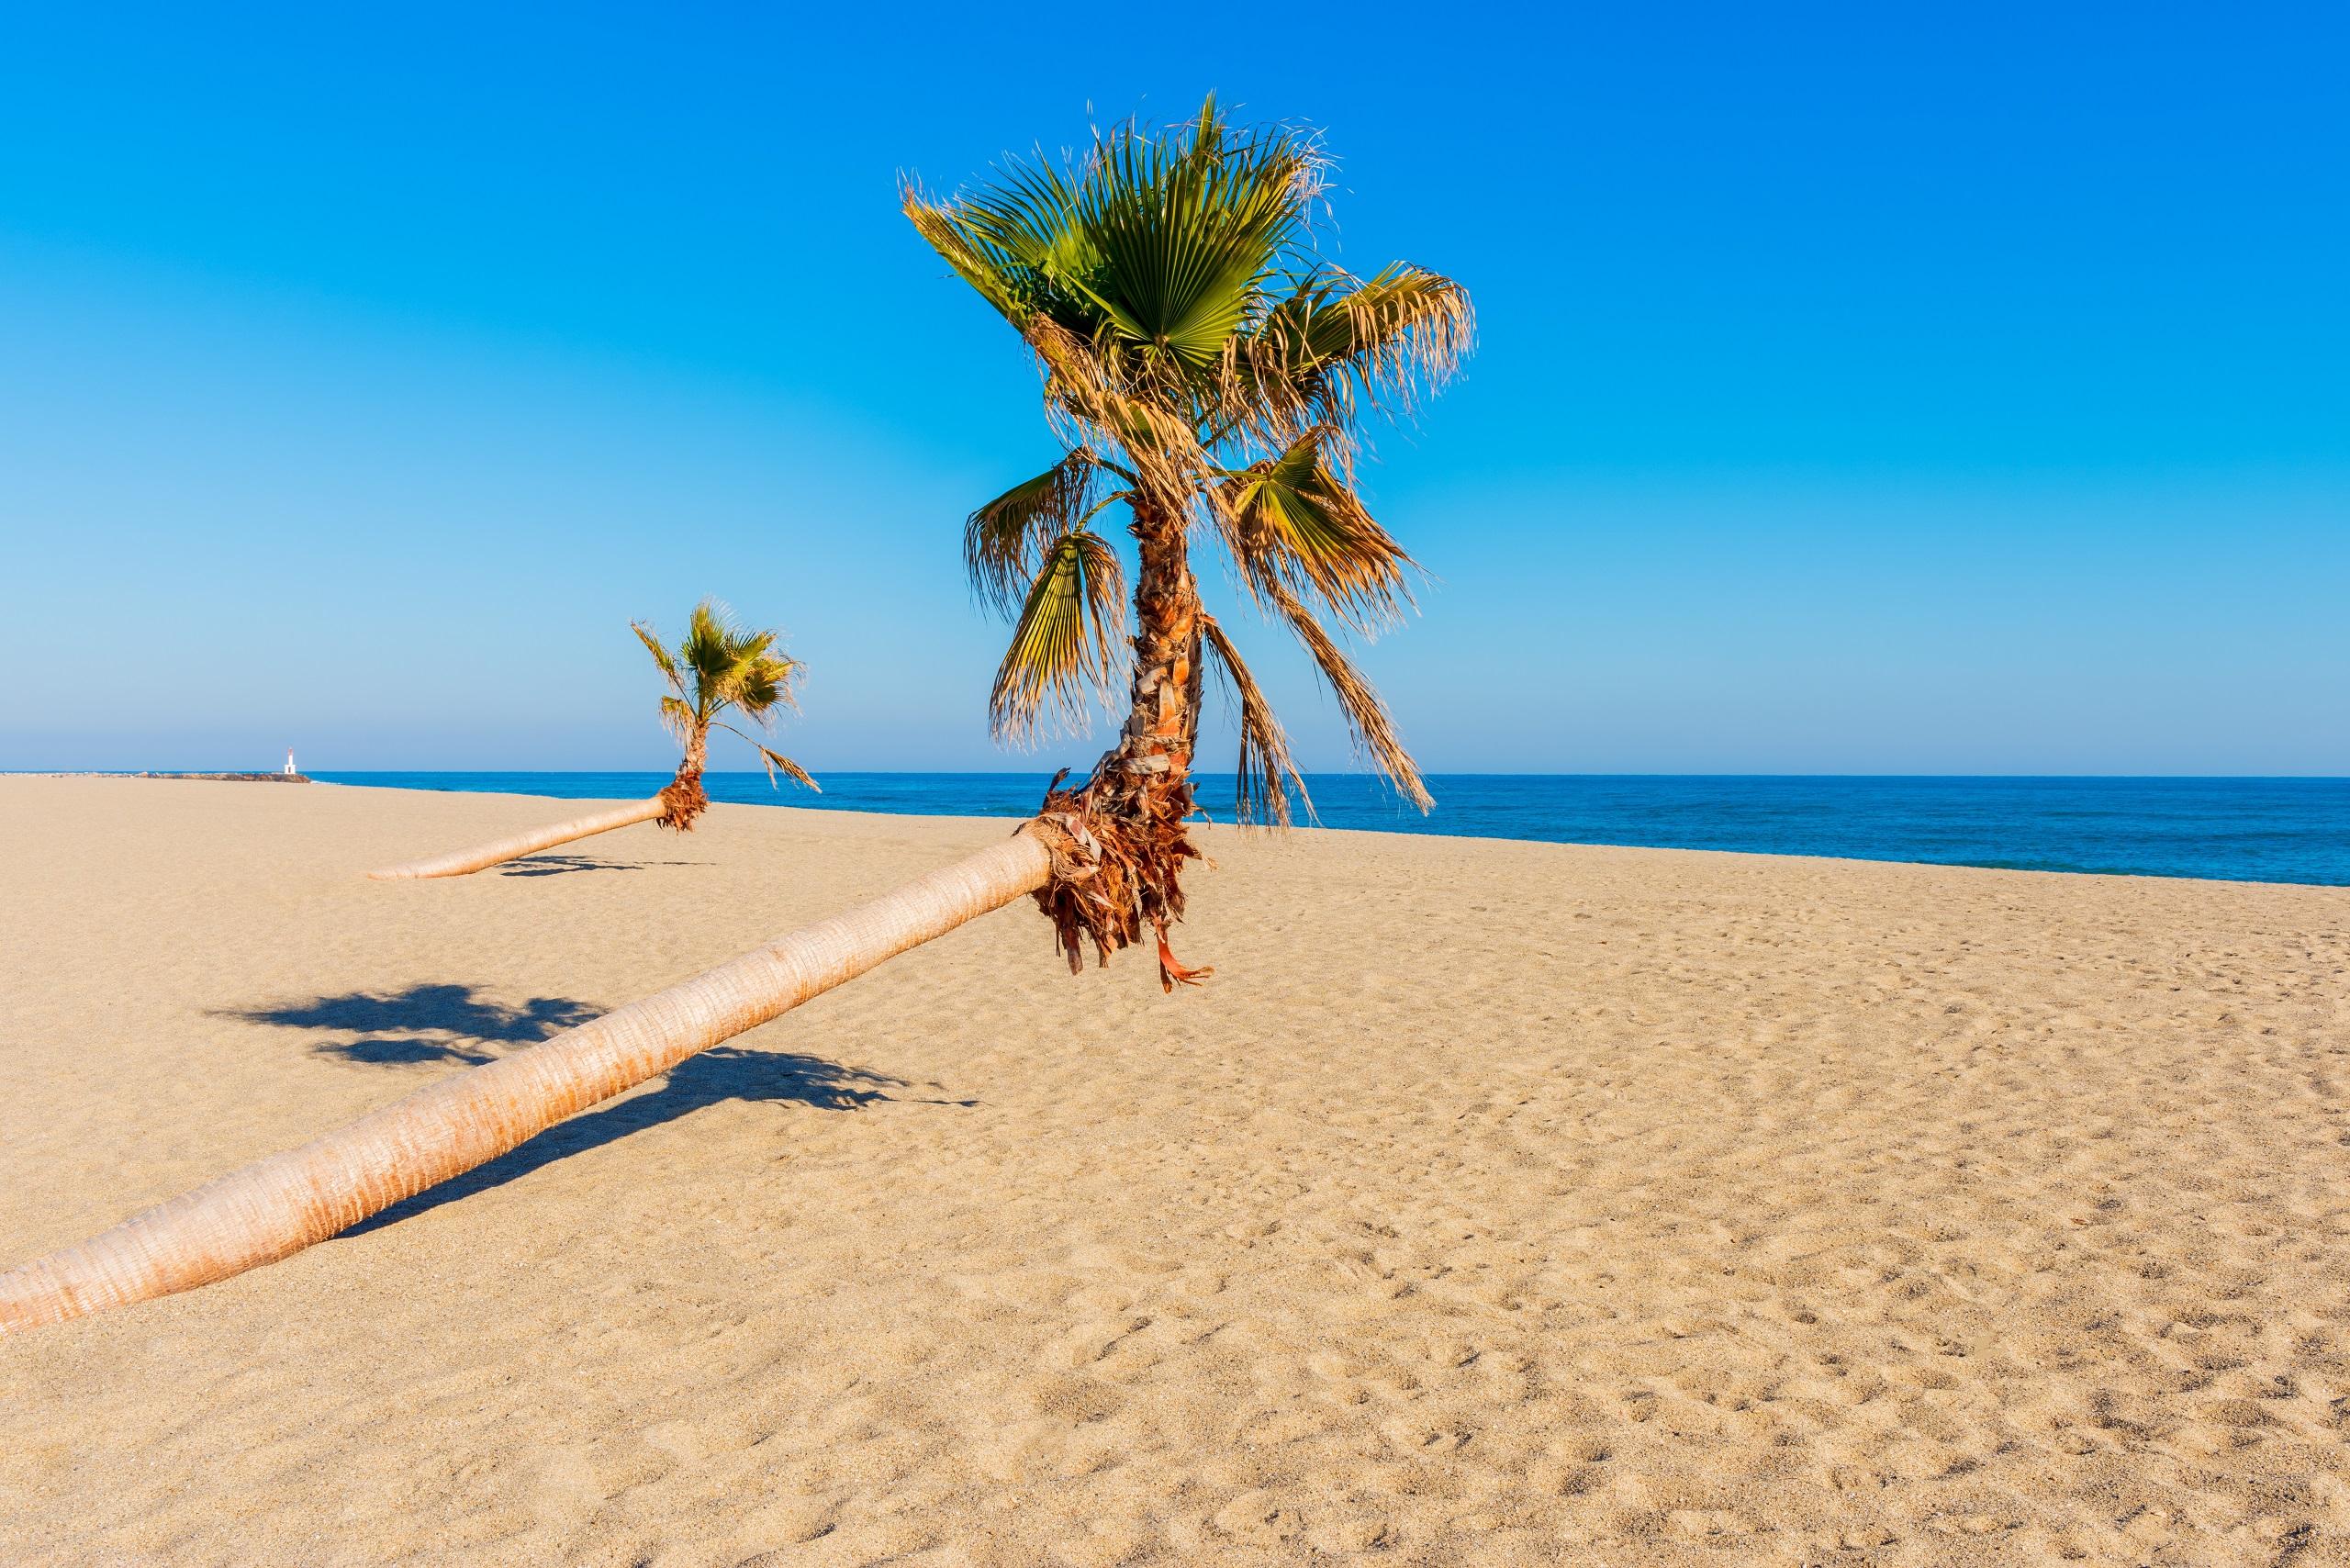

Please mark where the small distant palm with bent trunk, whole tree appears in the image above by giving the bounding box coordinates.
[366,599,818,881]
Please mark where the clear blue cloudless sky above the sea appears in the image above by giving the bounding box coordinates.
[0,5,2350,773]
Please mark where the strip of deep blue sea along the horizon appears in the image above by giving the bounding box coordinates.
[315,773,2350,886]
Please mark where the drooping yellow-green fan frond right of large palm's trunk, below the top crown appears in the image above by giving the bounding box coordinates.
[1222,425,1413,634]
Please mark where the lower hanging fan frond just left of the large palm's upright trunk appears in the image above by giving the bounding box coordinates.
[987,529,1125,741]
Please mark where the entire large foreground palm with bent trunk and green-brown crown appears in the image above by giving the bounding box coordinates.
[0,101,1469,1330]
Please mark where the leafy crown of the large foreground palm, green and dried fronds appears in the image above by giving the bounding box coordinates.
[905,96,1472,821]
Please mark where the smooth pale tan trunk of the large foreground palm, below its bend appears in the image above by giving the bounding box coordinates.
[0,830,1053,1333]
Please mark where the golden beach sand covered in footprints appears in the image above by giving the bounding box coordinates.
[0,778,2350,1565]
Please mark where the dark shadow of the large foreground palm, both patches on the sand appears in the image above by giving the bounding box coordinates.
[226,985,954,1237]
